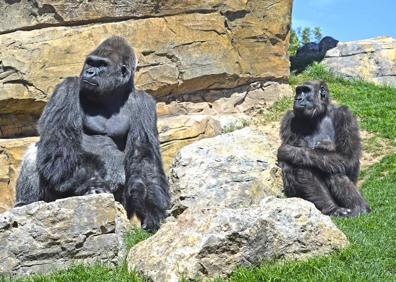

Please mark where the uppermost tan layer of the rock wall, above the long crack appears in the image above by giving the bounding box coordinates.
[0,0,291,33]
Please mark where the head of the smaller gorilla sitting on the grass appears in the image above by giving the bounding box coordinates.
[293,81,329,118]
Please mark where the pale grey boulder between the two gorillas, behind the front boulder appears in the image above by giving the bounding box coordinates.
[170,127,282,216]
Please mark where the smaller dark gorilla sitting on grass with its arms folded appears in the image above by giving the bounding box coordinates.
[278,81,370,217]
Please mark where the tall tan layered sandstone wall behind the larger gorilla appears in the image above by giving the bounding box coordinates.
[0,0,292,212]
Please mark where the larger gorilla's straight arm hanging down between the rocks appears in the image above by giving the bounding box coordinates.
[125,92,170,230]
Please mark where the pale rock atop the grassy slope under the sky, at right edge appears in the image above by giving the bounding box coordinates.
[322,37,396,87]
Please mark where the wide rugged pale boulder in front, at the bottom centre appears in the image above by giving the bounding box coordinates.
[128,198,348,281]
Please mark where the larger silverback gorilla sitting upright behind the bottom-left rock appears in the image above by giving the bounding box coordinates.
[16,37,170,231]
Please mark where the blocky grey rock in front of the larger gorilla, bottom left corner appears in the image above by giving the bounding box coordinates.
[0,194,128,276]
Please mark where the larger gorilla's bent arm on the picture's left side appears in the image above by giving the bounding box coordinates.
[37,78,105,196]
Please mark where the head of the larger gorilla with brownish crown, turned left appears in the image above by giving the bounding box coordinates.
[80,37,136,99]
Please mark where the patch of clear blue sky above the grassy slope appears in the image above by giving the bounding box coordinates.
[292,0,396,41]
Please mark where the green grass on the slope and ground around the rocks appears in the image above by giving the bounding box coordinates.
[5,65,396,282]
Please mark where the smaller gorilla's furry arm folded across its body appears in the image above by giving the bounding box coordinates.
[278,107,360,174]
